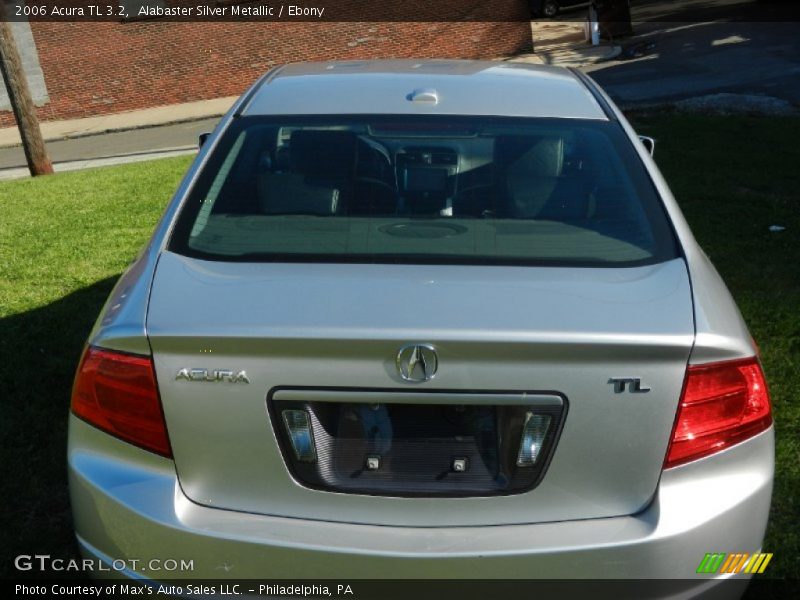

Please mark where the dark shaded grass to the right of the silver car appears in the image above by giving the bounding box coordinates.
[634,115,800,579]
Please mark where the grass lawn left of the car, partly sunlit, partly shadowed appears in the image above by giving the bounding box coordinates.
[0,157,191,577]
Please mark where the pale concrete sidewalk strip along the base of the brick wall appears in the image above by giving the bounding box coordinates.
[0,96,237,148]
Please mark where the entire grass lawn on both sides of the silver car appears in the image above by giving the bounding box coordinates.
[0,114,800,578]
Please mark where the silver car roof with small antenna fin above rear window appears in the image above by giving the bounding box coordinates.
[240,60,607,120]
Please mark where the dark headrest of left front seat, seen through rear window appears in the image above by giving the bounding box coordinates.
[289,130,356,177]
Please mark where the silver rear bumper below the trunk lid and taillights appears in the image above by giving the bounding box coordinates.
[68,417,774,589]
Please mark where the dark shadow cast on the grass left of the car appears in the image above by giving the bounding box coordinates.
[0,277,117,577]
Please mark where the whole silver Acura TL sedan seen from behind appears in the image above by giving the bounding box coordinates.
[68,61,773,590]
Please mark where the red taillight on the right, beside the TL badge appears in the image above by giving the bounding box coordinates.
[664,357,772,468]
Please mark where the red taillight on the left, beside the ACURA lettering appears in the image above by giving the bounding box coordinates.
[72,346,172,457]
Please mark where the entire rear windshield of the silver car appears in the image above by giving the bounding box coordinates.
[170,116,676,266]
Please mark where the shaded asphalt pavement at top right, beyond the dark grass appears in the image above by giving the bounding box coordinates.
[533,0,800,106]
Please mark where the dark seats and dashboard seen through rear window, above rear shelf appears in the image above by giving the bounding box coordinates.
[209,127,630,221]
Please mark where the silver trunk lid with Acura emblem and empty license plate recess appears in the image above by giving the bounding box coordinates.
[147,252,694,526]
